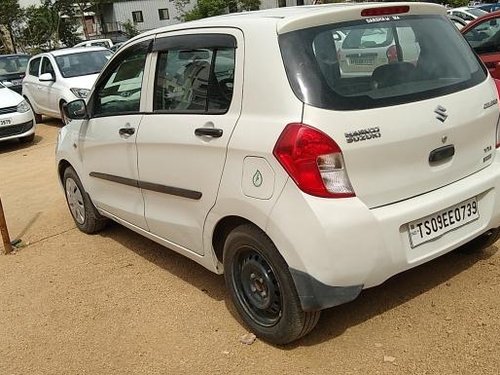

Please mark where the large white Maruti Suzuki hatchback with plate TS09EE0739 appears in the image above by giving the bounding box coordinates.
[57,3,500,344]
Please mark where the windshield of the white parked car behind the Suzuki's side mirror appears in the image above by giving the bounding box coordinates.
[55,50,112,78]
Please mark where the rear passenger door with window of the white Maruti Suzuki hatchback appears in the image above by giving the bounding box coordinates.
[137,29,243,254]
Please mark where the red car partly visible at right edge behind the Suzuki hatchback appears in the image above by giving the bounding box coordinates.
[462,16,500,79]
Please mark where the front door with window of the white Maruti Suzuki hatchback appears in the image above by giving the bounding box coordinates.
[80,38,152,229]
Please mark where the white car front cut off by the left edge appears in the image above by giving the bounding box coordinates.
[0,83,36,143]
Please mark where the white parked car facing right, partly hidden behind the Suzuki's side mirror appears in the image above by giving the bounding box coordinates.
[23,47,112,122]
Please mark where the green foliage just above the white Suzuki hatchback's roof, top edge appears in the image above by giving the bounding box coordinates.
[175,0,260,21]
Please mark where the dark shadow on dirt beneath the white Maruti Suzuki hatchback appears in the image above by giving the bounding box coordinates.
[95,223,498,350]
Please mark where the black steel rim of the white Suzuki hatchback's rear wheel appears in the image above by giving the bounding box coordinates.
[232,248,283,327]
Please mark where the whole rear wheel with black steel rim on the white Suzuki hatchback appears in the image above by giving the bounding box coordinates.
[223,224,321,345]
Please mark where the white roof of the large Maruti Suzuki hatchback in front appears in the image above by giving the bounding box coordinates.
[130,2,446,41]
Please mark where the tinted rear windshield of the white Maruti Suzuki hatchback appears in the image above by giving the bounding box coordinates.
[279,16,487,110]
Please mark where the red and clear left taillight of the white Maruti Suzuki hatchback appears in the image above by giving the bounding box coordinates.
[273,123,355,198]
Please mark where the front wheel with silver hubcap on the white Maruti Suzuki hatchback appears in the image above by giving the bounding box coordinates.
[63,167,107,234]
